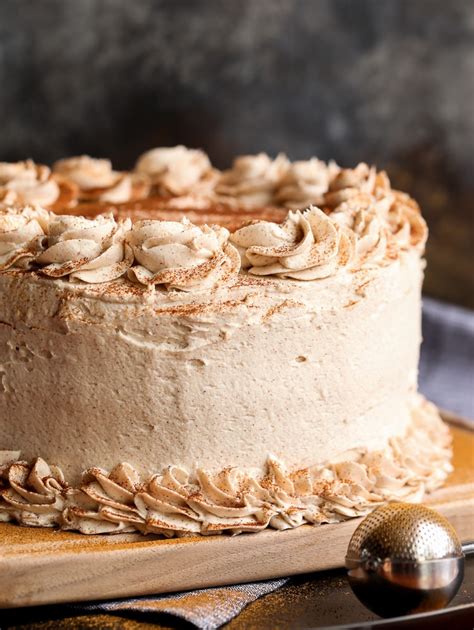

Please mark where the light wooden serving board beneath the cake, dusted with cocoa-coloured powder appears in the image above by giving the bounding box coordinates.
[0,414,474,608]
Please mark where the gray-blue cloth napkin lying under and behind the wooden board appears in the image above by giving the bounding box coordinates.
[62,298,474,630]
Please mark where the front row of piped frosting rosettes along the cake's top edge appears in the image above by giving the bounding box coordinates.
[0,169,427,291]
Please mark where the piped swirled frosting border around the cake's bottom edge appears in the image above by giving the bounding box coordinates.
[0,400,452,537]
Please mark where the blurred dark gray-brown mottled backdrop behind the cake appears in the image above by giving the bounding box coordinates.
[0,0,474,306]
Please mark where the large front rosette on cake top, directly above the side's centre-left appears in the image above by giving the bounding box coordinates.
[128,219,240,291]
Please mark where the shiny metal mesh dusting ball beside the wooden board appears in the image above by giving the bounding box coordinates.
[346,503,464,617]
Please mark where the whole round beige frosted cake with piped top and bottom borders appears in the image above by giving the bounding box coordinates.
[0,147,451,536]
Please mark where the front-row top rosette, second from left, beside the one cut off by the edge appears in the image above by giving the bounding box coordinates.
[35,215,133,283]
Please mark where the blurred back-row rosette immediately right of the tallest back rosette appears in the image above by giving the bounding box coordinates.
[216,153,290,207]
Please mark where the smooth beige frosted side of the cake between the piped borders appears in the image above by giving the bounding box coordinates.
[0,243,422,481]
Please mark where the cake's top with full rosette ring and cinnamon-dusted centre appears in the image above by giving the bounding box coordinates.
[0,146,427,291]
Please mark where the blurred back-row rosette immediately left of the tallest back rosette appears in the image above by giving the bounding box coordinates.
[53,155,150,203]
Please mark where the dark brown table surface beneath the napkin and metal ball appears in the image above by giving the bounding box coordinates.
[4,555,474,630]
